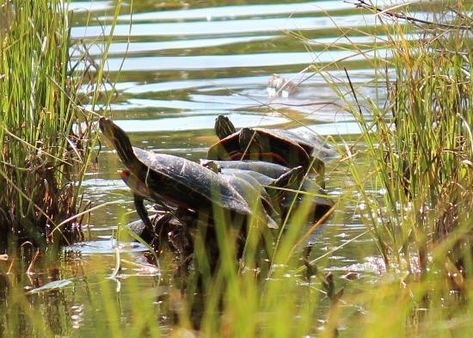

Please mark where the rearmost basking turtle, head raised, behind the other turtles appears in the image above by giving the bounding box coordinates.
[207,115,325,176]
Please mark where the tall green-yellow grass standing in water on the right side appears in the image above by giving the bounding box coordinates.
[347,0,473,278]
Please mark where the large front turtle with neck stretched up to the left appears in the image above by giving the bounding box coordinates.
[99,117,274,243]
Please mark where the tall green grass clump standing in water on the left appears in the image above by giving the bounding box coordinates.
[0,0,97,247]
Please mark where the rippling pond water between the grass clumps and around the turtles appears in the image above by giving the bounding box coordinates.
[2,0,390,336]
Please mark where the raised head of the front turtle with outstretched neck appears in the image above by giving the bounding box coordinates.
[99,117,136,167]
